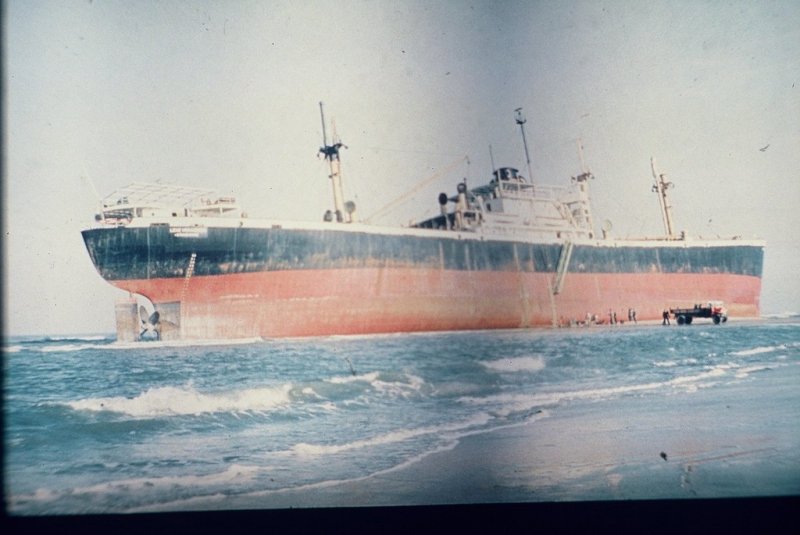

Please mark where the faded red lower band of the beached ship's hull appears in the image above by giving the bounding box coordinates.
[113,268,761,339]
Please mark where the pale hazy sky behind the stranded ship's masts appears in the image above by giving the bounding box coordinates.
[3,0,800,335]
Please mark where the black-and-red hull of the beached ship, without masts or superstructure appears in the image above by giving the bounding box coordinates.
[84,226,763,339]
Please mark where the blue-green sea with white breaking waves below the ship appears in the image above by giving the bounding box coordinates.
[3,318,800,515]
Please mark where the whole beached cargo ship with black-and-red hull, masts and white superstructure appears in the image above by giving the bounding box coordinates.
[82,104,765,341]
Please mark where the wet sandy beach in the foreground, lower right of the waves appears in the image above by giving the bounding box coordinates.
[158,360,800,511]
